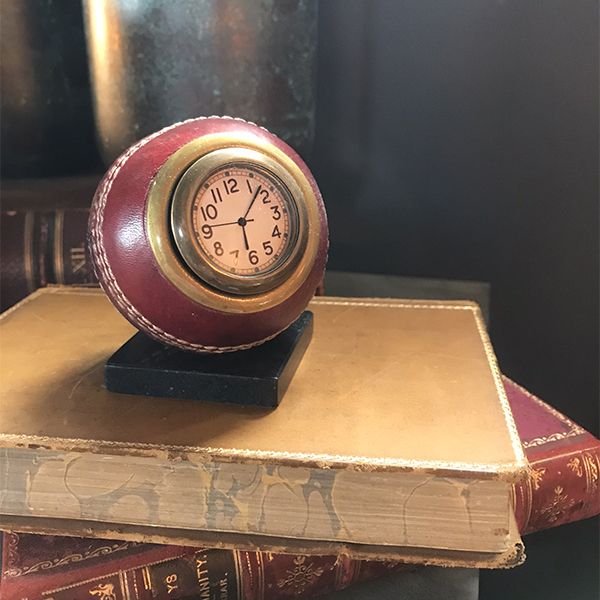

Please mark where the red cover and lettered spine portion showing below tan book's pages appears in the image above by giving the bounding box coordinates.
[0,532,406,600]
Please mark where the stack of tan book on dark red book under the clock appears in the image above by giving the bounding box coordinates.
[0,287,600,600]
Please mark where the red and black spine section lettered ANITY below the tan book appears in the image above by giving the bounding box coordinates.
[28,550,408,600]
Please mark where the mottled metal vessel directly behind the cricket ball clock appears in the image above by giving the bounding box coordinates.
[84,0,317,164]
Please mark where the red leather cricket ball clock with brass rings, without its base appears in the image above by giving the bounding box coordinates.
[89,117,328,352]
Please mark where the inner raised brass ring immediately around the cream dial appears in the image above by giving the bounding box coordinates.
[171,147,307,295]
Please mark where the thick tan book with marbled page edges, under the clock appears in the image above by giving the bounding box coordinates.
[0,287,526,566]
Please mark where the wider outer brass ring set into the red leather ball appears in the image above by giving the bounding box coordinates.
[146,132,321,313]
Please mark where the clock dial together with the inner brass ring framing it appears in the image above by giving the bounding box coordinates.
[171,148,306,295]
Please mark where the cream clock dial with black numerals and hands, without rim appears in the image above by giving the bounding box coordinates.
[192,164,296,277]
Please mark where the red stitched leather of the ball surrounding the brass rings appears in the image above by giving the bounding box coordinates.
[90,117,328,350]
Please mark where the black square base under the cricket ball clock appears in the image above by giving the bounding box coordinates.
[104,311,313,407]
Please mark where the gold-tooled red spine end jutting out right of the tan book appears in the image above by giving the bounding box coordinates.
[513,439,600,534]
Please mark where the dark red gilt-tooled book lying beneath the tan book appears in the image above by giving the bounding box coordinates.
[0,378,600,600]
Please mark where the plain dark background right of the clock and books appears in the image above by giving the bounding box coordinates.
[312,0,599,600]
